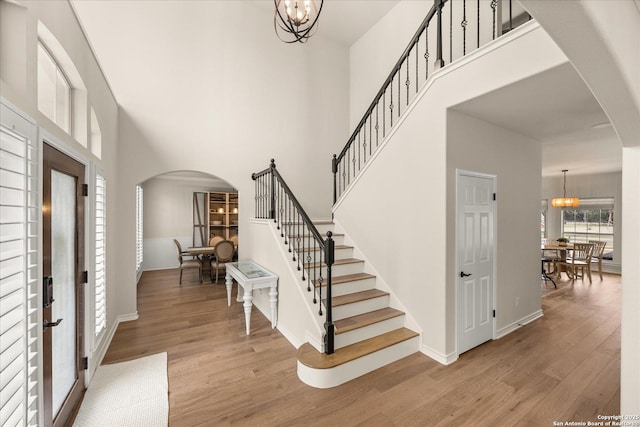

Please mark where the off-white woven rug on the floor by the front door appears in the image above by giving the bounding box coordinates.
[73,353,169,427]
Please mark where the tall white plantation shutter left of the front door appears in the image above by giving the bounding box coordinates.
[0,105,40,426]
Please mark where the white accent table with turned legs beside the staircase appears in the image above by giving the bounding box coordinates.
[225,261,278,335]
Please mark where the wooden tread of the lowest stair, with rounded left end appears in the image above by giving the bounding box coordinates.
[298,328,418,369]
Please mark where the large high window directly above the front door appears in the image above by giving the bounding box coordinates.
[38,42,71,133]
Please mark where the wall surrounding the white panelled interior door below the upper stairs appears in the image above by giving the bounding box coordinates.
[446,110,542,352]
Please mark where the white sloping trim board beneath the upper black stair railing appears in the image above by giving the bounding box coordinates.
[331,20,540,212]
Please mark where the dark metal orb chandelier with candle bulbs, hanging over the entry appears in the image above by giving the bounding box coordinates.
[273,0,324,43]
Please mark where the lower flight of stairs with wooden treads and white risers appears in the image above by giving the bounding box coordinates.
[288,222,419,388]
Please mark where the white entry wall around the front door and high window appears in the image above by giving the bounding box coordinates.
[0,1,120,382]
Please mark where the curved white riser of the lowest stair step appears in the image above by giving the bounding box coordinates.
[298,337,420,388]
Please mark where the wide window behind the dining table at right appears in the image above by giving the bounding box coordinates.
[562,197,614,250]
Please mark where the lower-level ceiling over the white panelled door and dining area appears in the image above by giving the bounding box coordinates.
[453,63,622,176]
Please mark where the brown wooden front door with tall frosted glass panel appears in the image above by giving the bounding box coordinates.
[42,144,84,426]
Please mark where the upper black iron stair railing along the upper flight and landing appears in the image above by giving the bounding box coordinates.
[331,0,531,204]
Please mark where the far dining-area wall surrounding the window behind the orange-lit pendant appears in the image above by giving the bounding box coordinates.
[542,171,623,273]
